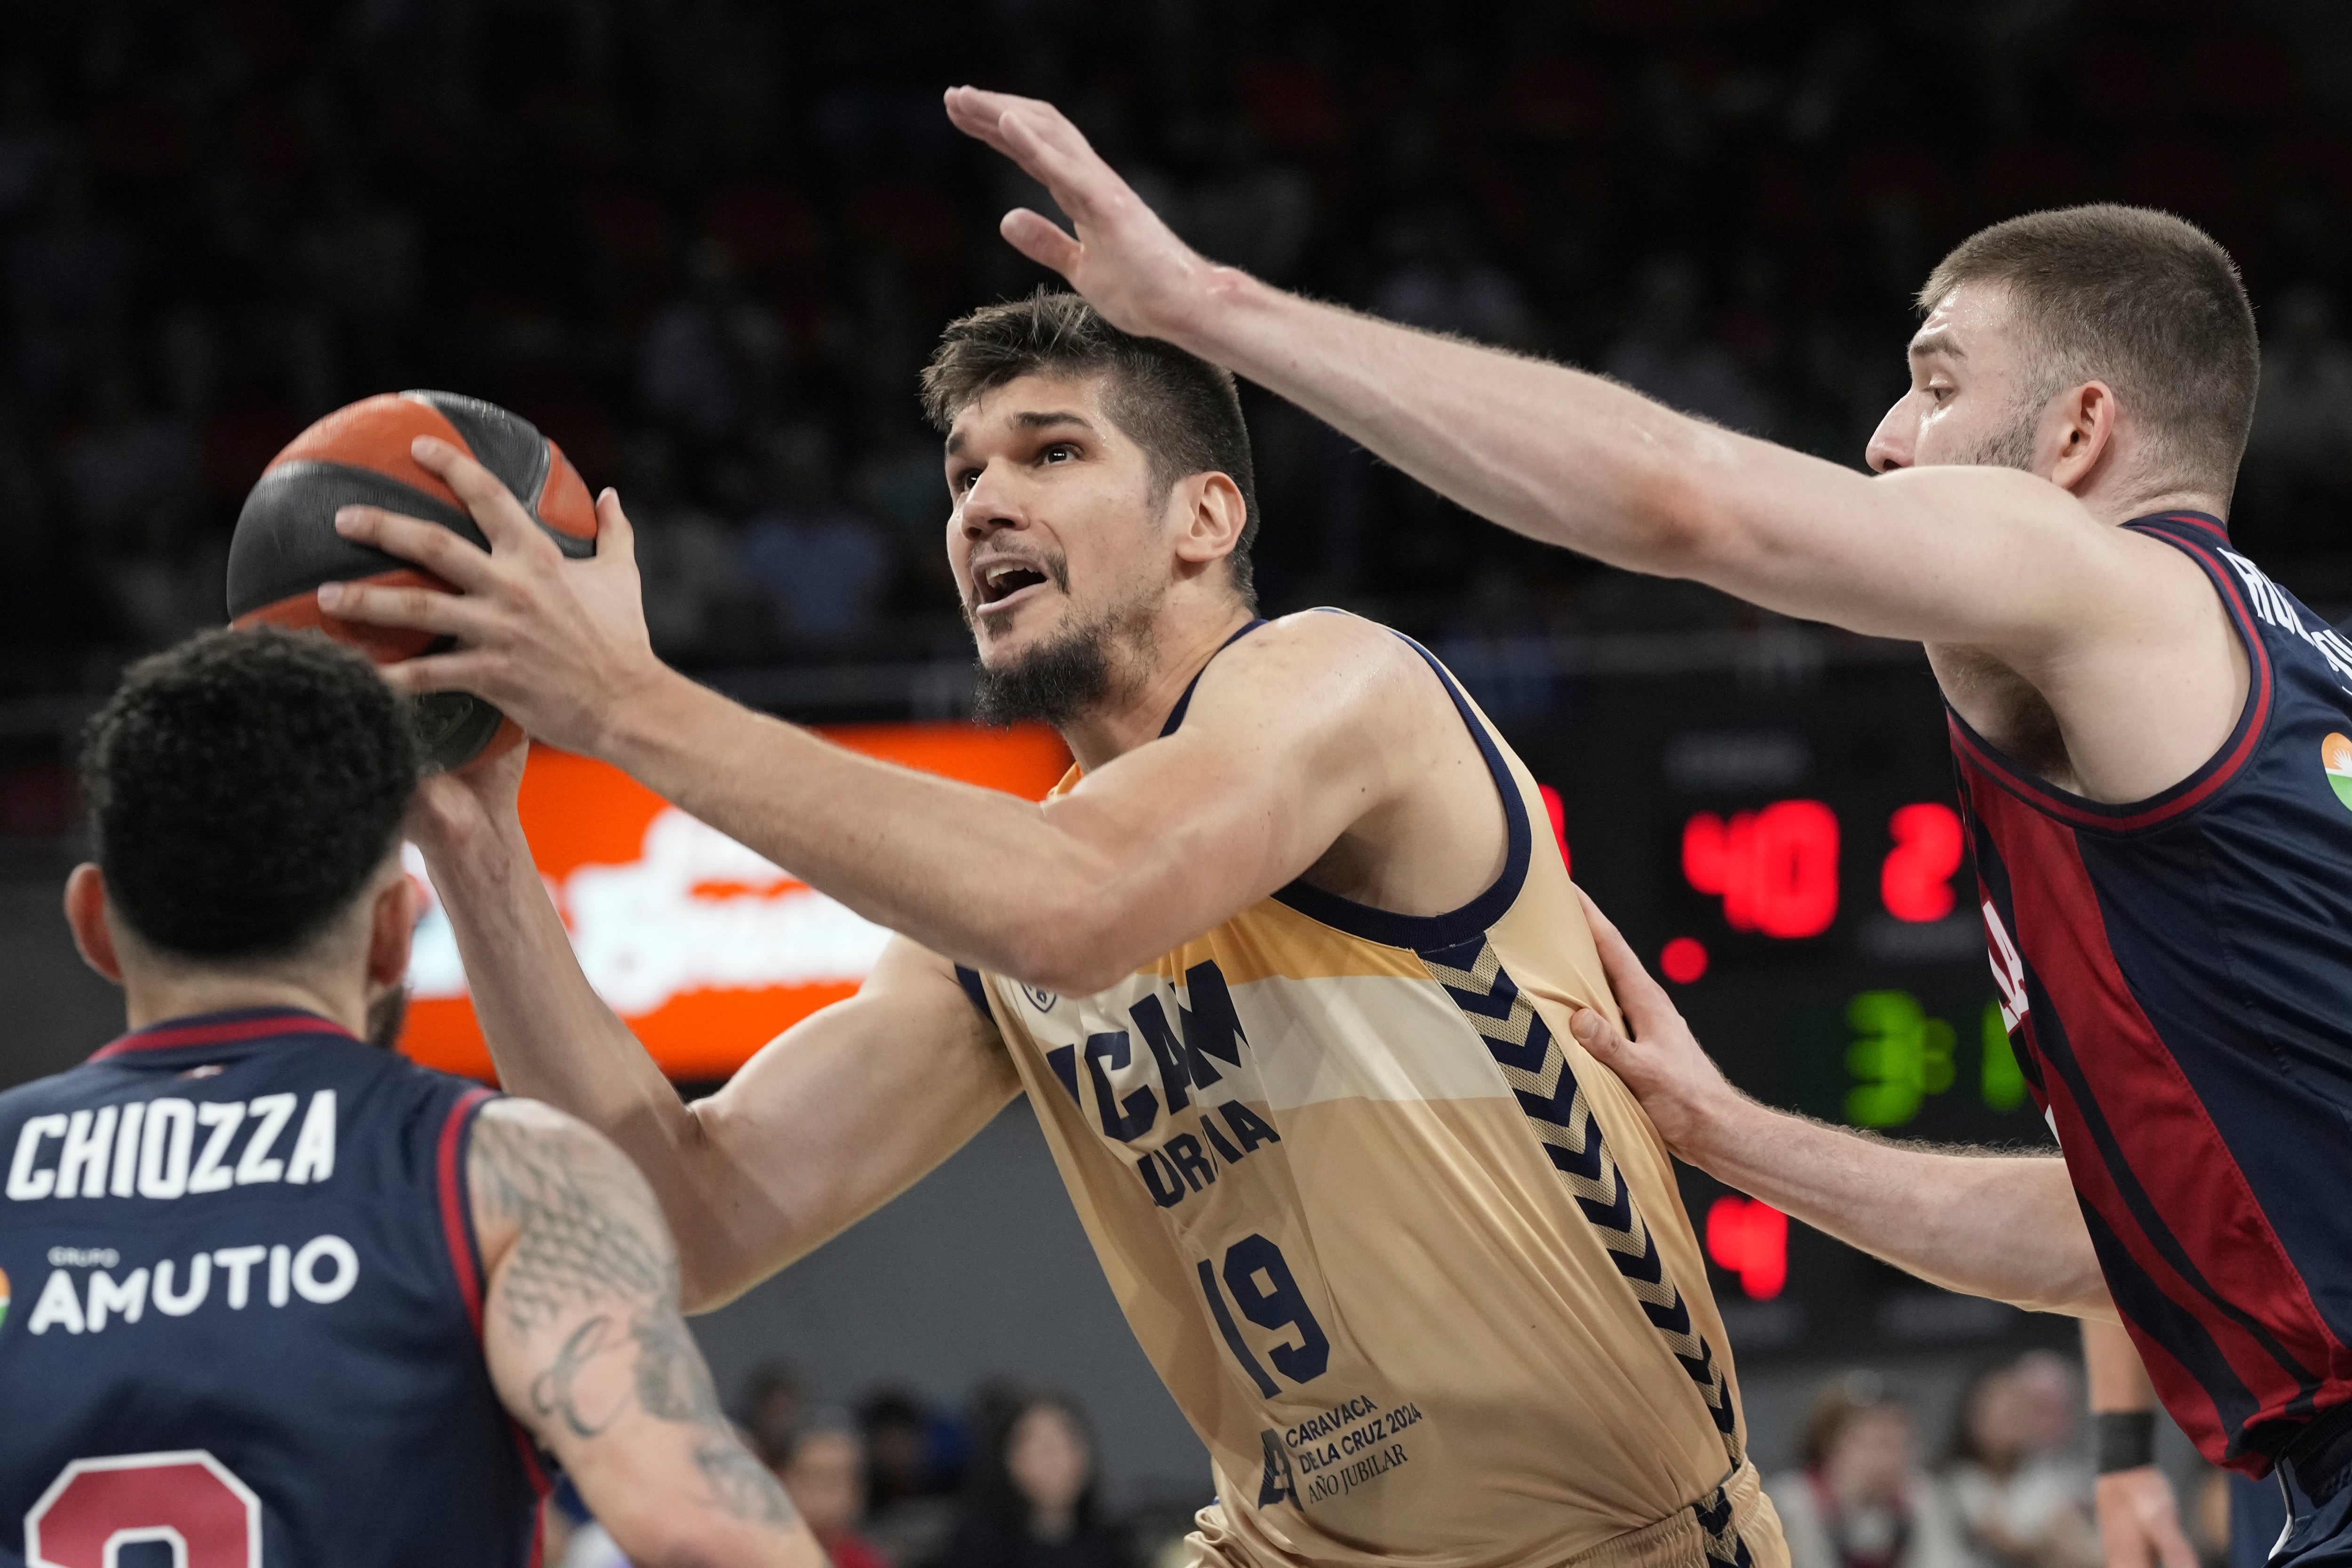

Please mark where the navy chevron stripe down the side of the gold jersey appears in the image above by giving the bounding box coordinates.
[1421,936,1745,1476]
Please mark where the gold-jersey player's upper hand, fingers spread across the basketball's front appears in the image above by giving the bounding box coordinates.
[318,435,663,755]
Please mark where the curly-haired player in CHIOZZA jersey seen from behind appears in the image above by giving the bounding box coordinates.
[0,630,823,1568]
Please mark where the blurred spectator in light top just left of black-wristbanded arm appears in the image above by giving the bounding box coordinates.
[1945,1352,2100,1568]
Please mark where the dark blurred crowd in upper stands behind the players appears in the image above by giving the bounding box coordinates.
[0,0,2352,696]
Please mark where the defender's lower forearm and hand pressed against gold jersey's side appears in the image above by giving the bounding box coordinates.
[1569,898,2114,1321]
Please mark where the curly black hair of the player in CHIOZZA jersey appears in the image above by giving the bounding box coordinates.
[82,628,421,964]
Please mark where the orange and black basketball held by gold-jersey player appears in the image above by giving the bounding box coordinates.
[228,392,595,769]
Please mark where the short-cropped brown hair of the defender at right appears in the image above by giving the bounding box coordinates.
[1919,205,2263,496]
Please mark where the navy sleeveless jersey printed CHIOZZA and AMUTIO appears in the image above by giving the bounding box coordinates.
[0,1009,543,1568]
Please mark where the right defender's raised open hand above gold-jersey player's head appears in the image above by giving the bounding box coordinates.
[948,87,1240,343]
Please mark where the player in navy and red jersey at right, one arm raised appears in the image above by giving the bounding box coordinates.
[922,87,2352,1561]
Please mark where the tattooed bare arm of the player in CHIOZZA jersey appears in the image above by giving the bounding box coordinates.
[466,1100,826,1568]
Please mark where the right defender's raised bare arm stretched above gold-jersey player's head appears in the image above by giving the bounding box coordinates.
[948,87,2230,757]
